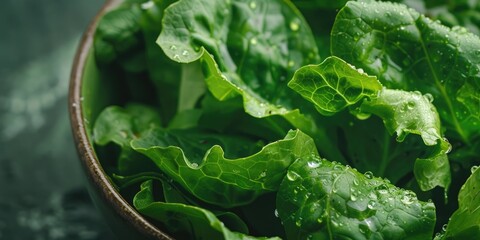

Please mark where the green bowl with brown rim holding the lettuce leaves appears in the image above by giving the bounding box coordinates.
[68,0,173,239]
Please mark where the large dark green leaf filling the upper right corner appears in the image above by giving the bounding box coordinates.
[331,1,480,144]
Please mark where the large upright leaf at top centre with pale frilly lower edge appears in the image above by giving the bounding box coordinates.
[157,0,319,130]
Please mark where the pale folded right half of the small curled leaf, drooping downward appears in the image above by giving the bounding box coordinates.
[360,89,452,191]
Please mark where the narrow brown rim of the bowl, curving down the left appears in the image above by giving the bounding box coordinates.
[68,0,173,240]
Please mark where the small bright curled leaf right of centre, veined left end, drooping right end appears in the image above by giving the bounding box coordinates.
[288,57,451,190]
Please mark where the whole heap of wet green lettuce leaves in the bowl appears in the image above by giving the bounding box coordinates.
[91,0,480,239]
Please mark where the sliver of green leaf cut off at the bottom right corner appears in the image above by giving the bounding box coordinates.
[442,166,480,239]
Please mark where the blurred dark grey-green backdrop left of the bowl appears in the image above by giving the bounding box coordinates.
[0,0,112,240]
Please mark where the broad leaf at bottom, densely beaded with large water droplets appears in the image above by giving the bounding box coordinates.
[277,157,435,239]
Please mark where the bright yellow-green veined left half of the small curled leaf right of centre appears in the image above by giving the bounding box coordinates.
[288,57,382,116]
